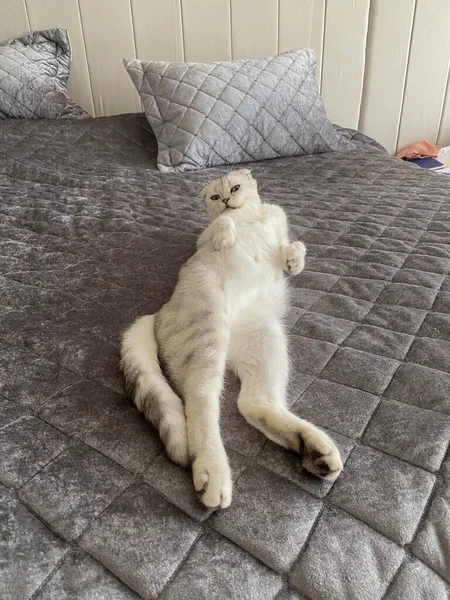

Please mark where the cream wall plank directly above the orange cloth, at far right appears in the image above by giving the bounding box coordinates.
[397,0,450,149]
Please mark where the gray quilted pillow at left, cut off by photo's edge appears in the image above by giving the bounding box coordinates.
[0,29,88,120]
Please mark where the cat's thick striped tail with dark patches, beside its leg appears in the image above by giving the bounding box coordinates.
[120,315,189,466]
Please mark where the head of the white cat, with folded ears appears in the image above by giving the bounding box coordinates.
[200,169,261,219]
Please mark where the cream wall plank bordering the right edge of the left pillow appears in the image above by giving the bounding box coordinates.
[27,0,94,115]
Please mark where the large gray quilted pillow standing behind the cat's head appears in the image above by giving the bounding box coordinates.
[124,50,355,172]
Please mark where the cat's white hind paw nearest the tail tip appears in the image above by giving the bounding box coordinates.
[192,450,232,508]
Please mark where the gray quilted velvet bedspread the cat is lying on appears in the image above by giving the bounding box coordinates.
[0,115,450,600]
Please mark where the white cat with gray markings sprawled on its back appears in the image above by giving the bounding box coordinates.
[121,169,342,508]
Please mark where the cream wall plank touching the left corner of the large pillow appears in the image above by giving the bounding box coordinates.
[77,0,140,116]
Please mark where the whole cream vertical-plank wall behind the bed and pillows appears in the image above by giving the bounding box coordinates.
[0,0,450,152]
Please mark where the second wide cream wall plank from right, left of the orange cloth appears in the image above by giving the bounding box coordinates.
[359,0,415,152]
